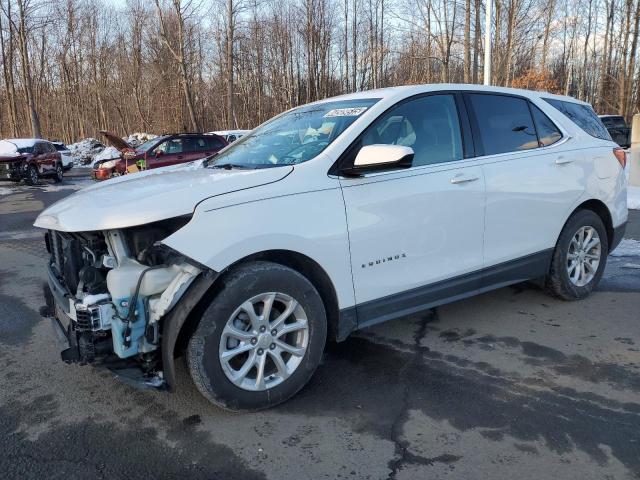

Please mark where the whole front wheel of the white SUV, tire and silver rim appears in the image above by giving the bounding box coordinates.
[187,262,327,410]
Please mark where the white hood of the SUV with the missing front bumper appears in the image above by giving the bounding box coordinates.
[34,163,293,232]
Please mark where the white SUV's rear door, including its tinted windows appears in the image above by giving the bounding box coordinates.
[465,93,584,276]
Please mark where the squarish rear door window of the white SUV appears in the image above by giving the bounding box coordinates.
[469,93,538,155]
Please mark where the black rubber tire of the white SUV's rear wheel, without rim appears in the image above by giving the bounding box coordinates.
[545,210,609,300]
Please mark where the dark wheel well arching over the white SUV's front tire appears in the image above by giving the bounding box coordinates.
[170,250,340,353]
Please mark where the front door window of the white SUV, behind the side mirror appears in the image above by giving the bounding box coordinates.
[361,94,463,166]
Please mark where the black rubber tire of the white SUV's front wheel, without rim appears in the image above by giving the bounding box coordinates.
[187,262,327,411]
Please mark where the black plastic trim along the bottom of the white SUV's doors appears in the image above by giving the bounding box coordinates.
[337,248,553,341]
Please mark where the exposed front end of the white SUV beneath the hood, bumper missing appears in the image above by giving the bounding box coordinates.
[45,217,203,387]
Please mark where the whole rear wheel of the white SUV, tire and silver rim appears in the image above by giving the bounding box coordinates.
[546,210,609,300]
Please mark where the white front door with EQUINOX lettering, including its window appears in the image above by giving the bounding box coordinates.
[341,94,484,326]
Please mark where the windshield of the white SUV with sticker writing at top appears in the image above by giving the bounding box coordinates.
[209,98,379,168]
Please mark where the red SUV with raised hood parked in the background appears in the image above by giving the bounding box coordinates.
[91,131,227,180]
